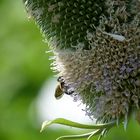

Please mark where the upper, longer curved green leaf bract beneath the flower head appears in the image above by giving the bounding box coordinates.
[40,118,115,132]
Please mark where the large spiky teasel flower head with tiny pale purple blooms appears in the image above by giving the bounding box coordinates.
[23,0,140,139]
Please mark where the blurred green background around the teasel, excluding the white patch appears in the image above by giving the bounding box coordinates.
[0,0,140,140]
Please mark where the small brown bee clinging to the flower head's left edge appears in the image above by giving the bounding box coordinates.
[54,76,74,99]
